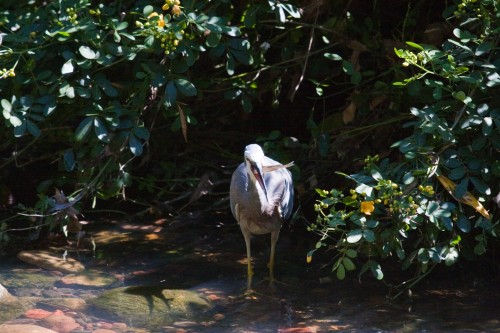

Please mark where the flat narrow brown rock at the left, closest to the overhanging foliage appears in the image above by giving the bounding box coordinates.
[17,250,85,273]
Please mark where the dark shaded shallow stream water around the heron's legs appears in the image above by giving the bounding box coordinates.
[0,211,500,333]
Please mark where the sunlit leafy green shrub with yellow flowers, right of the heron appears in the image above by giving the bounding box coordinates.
[308,0,500,292]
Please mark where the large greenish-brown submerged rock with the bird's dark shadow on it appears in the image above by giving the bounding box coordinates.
[91,286,213,327]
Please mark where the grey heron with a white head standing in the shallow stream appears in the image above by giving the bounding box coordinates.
[229,144,293,286]
